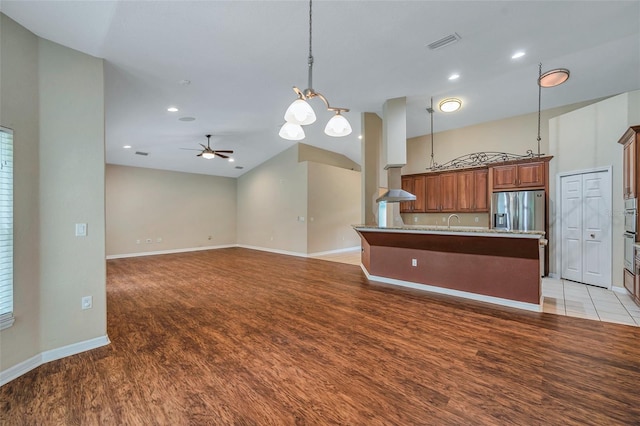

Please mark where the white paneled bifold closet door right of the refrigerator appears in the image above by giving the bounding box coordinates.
[560,171,611,287]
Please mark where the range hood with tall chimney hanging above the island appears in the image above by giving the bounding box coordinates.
[376,98,416,203]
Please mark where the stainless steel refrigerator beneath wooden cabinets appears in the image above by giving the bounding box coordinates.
[491,191,545,231]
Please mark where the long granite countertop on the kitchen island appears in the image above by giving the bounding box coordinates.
[352,225,545,238]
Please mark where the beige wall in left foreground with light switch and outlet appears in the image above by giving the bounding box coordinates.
[0,15,106,370]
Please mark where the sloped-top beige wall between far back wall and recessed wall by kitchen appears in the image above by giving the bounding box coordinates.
[237,145,307,254]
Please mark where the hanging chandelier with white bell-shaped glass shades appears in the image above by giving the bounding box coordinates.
[279,0,352,141]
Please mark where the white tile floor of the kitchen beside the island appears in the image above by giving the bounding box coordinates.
[542,278,640,326]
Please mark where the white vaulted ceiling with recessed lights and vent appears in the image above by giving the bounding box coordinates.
[0,0,640,177]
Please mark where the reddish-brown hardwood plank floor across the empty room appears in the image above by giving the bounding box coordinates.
[0,248,640,425]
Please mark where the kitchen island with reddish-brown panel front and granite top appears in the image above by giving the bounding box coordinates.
[354,225,544,311]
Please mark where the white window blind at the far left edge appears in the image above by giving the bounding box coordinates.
[0,127,13,330]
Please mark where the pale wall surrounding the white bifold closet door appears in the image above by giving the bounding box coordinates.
[549,91,640,287]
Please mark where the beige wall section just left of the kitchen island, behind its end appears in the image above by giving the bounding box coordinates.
[307,162,361,253]
